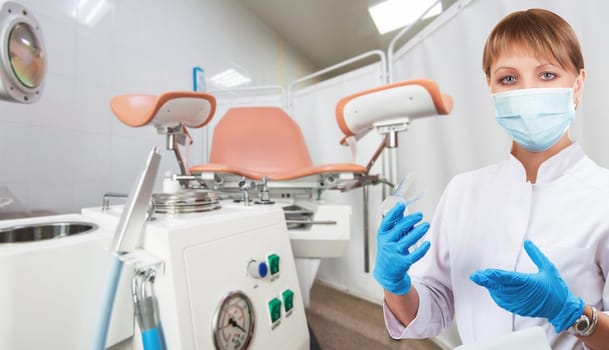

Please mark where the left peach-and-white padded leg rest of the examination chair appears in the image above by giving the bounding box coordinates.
[110,91,216,128]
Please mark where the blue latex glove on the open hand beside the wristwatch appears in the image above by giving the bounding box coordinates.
[470,240,584,333]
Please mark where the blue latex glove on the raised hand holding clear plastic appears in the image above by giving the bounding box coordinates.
[372,203,430,295]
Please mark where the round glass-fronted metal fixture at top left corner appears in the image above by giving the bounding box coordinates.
[0,2,46,103]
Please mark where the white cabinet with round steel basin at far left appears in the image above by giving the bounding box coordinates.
[0,214,133,349]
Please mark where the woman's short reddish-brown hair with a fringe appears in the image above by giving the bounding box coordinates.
[482,9,584,78]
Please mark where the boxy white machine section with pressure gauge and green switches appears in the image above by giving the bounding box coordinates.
[82,165,309,350]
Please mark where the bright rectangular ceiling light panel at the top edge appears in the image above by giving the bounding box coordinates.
[368,0,442,34]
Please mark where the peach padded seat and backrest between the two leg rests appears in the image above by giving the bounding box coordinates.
[190,107,367,181]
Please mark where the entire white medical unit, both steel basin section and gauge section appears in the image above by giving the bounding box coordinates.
[0,152,309,350]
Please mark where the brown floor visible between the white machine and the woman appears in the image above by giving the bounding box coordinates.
[306,282,442,350]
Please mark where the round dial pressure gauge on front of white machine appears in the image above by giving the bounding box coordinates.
[213,291,254,350]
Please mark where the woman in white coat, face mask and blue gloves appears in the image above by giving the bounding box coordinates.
[373,9,609,350]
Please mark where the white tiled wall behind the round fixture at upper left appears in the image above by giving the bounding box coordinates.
[0,0,313,214]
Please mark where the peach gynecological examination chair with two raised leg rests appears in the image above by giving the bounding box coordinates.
[112,79,452,304]
